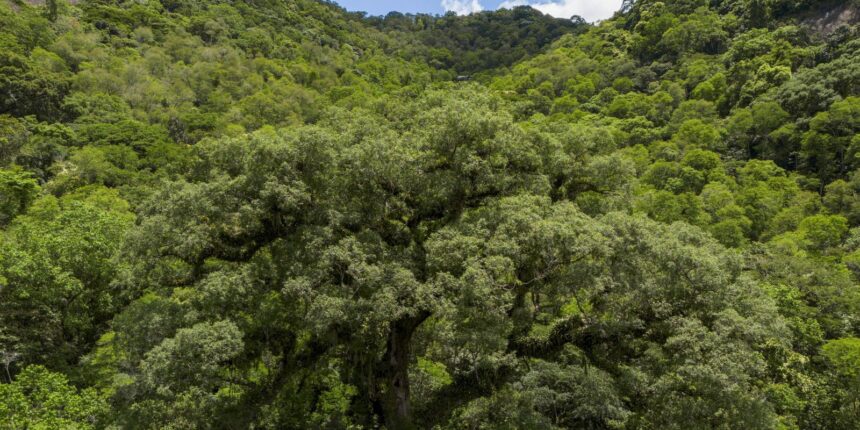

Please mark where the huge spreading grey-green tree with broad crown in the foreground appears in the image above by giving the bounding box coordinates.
[97,87,781,429]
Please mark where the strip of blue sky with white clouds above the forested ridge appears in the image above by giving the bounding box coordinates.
[336,0,622,21]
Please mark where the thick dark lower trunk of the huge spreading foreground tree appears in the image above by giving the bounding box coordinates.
[380,312,430,430]
